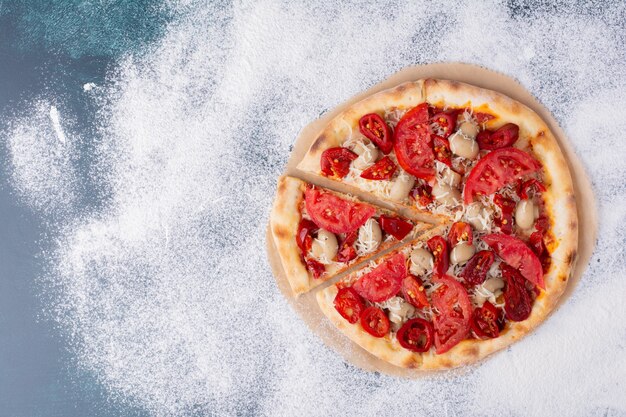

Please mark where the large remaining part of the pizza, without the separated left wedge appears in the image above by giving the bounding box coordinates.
[272,79,578,370]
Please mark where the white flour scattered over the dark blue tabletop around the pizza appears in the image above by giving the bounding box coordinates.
[1,1,626,416]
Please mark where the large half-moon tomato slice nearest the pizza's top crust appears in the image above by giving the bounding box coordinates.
[393,103,435,180]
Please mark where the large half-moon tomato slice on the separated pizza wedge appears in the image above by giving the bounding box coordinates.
[304,187,376,234]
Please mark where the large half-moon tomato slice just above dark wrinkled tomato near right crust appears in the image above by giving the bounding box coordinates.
[483,233,546,289]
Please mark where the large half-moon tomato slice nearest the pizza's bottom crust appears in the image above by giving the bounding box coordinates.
[431,275,472,354]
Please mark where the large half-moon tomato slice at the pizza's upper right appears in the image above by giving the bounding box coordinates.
[463,148,541,204]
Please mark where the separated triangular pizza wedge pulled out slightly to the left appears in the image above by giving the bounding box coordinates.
[270,176,432,295]
